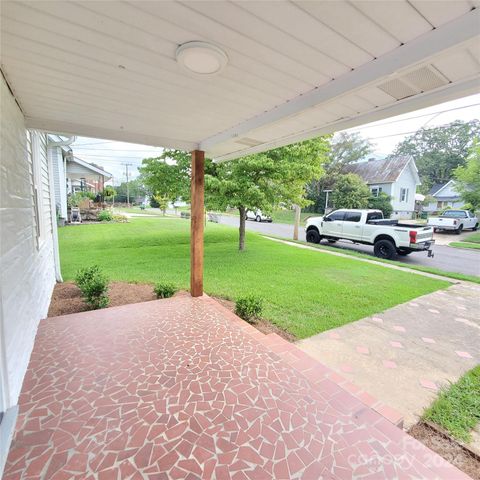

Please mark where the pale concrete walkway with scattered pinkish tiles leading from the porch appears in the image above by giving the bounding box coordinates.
[297,277,480,428]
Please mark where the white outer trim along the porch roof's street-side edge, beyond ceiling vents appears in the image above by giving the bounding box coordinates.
[214,77,479,162]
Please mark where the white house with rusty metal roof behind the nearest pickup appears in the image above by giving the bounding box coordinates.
[344,156,421,218]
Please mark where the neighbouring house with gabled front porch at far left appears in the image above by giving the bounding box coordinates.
[49,151,112,219]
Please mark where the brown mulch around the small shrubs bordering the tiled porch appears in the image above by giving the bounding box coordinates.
[48,282,296,342]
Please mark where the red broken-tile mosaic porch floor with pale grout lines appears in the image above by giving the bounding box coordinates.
[4,297,468,480]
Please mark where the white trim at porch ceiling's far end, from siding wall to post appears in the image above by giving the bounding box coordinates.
[25,117,198,152]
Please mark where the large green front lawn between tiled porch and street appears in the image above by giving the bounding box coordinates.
[59,217,449,338]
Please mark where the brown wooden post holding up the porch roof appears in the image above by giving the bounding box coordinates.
[190,150,205,297]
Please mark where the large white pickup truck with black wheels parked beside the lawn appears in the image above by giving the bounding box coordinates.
[305,209,435,260]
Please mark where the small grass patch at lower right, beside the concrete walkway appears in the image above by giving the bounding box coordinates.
[423,365,480,442]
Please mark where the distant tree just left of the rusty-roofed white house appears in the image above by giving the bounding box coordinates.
[307,132,373,212]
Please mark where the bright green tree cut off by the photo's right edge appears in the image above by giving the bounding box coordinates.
[454,138,480,210]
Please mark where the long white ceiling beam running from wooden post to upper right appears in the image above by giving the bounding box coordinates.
[199,9,480,151]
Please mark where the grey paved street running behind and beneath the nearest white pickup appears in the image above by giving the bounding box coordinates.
[215,215,480,276]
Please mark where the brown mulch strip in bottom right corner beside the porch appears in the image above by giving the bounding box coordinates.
[408,421,480,480]
